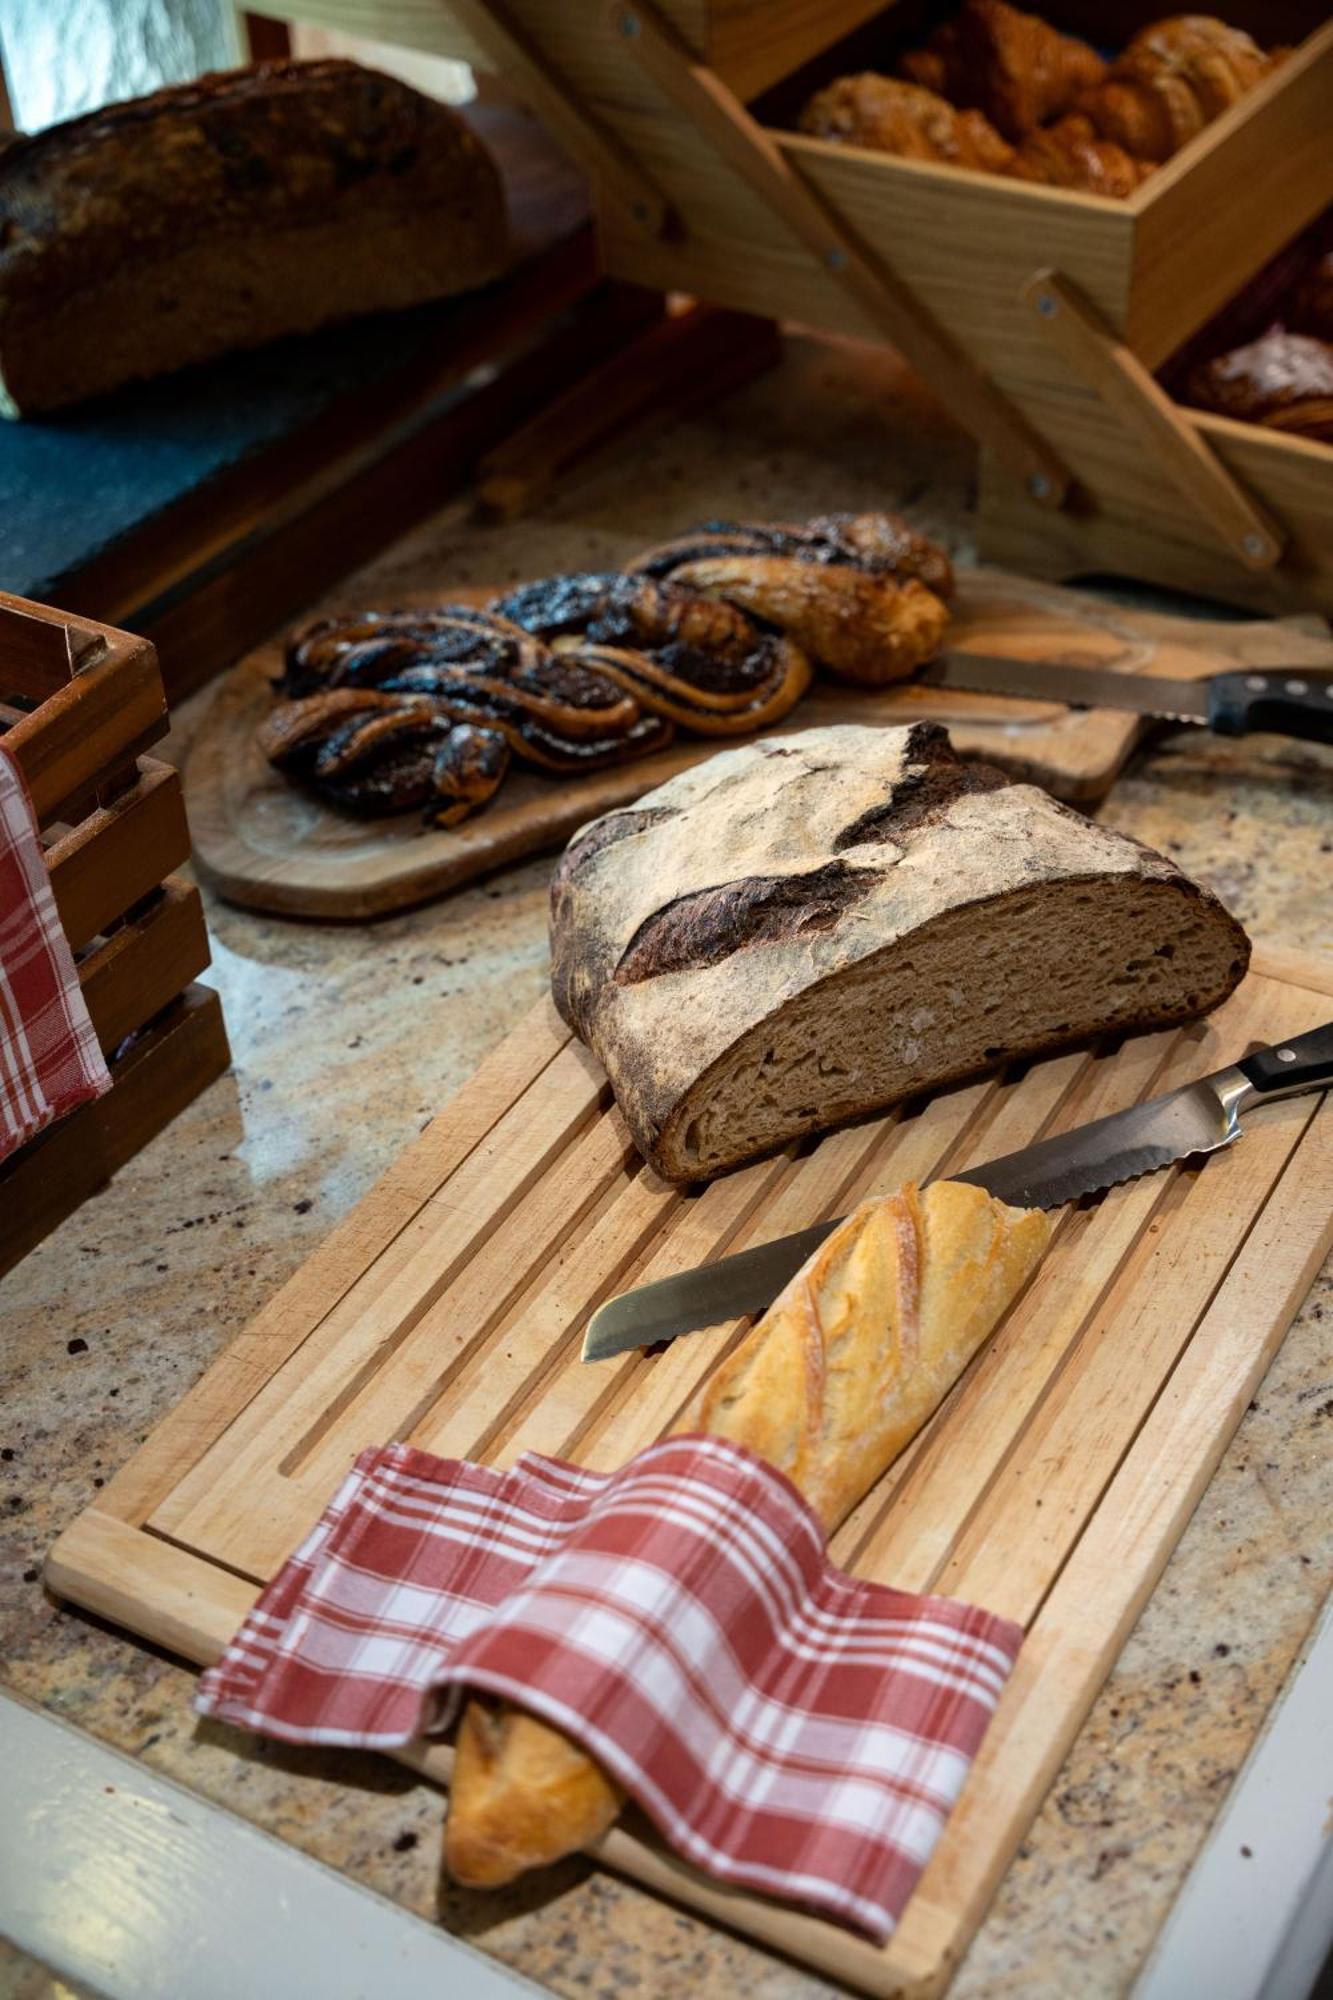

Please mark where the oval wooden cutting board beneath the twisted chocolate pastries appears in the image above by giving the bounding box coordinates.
[184,570,1333,918]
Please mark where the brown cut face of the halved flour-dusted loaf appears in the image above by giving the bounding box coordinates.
[658,876,1245,1180]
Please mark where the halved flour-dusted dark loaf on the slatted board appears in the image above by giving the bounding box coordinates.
[550,722,1249,1182]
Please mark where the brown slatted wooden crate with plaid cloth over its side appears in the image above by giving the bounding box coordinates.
[0,594,230,1274]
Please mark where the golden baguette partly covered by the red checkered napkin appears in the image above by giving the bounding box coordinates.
[444,1180,1051,1888]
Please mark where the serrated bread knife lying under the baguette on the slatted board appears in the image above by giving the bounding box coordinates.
[582,1022,1333,1362]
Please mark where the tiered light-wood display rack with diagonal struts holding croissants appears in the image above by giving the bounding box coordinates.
[244,0,1333,610]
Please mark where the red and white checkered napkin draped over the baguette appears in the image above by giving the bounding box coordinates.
[198,1436,1023,1942]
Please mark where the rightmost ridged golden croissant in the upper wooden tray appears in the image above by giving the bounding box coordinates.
[1077,14,1273,160]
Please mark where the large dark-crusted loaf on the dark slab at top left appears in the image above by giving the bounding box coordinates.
[0,60,508,416]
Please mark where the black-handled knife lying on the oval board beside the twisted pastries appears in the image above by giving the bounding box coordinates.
[915,652,1333,744]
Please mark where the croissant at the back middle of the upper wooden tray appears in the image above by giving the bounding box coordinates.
[899,0,1107,144]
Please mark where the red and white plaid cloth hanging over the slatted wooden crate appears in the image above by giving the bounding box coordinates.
[0,742,110,1160]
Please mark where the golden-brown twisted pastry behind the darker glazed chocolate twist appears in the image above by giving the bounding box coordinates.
[630,514,953,686]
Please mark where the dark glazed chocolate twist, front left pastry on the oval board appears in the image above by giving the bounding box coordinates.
[258,576,811,826]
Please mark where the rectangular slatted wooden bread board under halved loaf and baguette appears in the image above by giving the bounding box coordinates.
[48,954,1333,1996]
